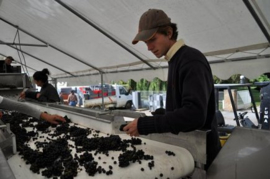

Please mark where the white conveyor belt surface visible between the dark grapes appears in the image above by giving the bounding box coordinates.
[8,114,194,179]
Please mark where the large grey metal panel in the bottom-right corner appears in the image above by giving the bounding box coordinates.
[207,127,270,179]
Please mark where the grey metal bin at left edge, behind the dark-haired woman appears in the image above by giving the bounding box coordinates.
[0,73,31,88]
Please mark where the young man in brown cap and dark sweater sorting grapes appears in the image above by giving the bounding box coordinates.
[124,9,220,169]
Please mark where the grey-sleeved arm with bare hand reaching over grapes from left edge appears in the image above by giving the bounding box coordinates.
[0,96,66,124]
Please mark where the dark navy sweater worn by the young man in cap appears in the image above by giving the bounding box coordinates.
[138,46,220,167]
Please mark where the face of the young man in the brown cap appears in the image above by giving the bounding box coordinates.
[145,33,172,58]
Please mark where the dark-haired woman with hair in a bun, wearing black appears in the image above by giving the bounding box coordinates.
[20,68,60,102]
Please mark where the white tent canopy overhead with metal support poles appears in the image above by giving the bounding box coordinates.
[0,0,270,85]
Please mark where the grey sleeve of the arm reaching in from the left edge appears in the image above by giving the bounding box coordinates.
[0,96,41,119]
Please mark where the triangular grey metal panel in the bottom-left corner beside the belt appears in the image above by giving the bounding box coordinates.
[0,148,15,179]
